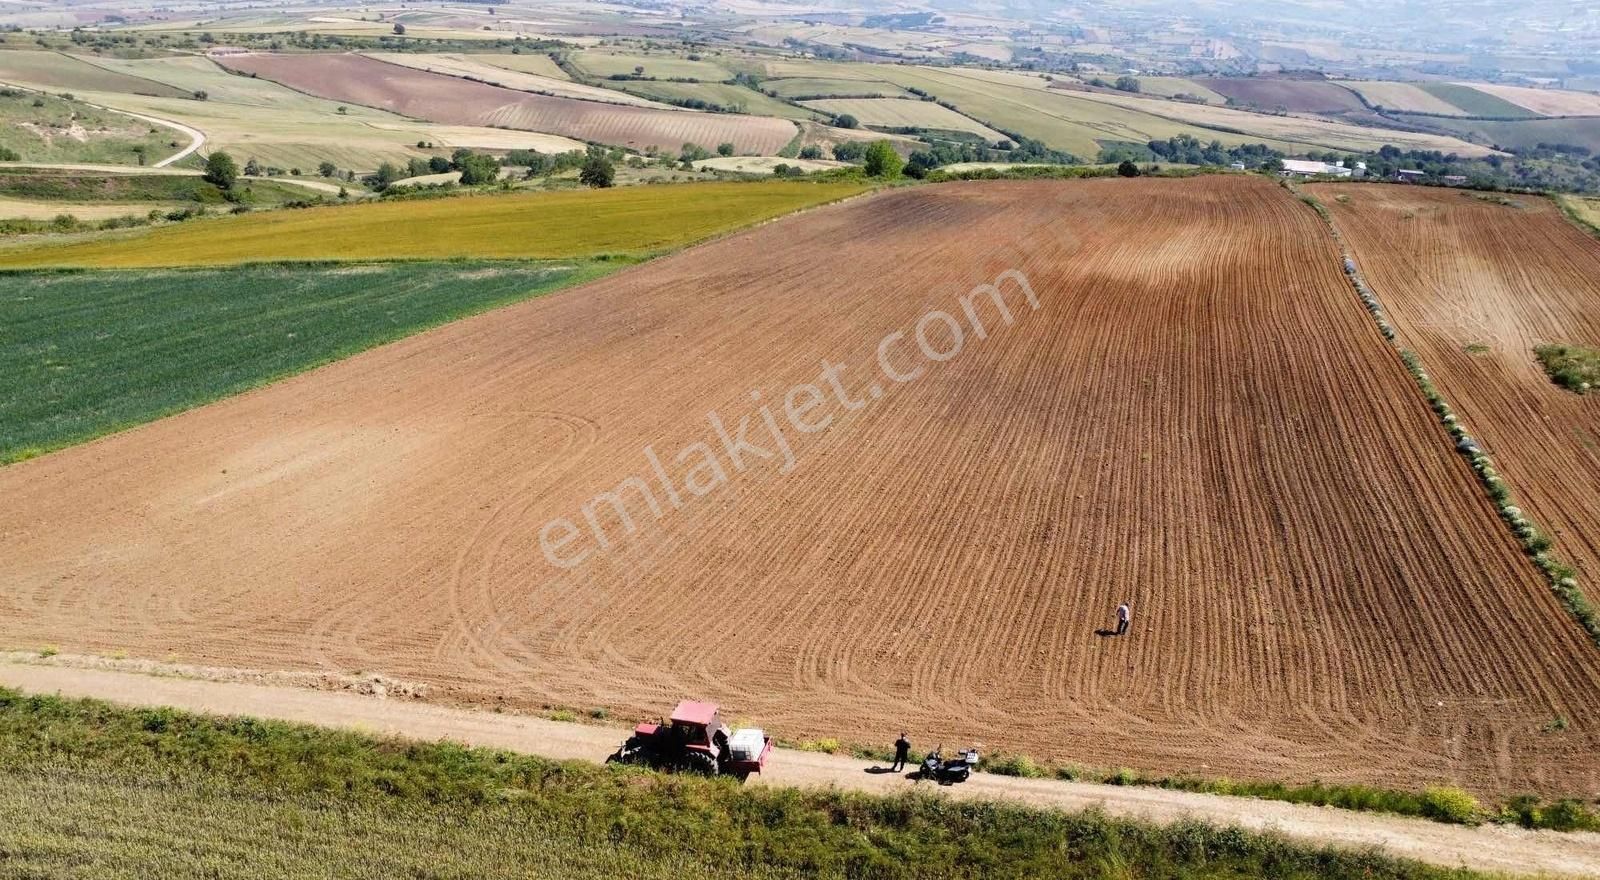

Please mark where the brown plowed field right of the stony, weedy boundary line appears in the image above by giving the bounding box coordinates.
[1312,186,1600,614]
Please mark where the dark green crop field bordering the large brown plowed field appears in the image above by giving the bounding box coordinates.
[0,261,621,464]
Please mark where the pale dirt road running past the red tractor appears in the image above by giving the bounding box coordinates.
[0,662,1600,875]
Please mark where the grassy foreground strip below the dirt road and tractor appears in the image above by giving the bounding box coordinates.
[0,690,1480,880]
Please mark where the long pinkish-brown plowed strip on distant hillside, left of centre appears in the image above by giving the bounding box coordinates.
[216,54,797,155]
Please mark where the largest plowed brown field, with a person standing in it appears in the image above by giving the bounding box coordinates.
[0,178,1600,794]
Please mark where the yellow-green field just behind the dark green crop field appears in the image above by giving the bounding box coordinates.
[0,181,869,267]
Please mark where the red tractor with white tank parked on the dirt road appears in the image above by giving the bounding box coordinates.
[606,699,773,782]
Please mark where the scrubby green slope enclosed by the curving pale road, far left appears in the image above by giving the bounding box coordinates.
[0,90,176,165]
